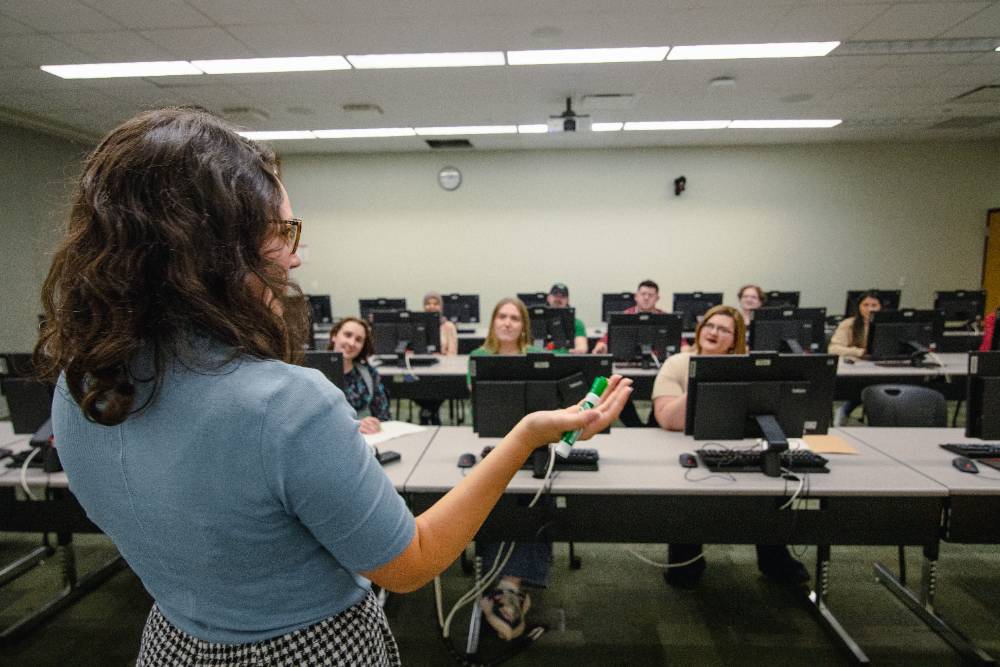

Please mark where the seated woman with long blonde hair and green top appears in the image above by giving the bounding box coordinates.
[469,297,552,640]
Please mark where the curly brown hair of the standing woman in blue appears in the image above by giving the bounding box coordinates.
[35,107,308,425]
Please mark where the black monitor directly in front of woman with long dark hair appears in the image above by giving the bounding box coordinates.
[865,308,944,365]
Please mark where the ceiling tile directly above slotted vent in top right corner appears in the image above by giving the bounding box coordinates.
[851,2,990,40]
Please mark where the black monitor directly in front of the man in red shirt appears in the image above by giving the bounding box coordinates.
[608,313,681,366]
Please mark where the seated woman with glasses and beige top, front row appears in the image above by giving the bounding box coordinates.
[653,306,809,587]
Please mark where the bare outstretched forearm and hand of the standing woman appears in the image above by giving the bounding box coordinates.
[362,375,632,593]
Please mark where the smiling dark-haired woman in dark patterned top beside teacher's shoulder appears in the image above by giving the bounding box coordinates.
[327,317,392,435]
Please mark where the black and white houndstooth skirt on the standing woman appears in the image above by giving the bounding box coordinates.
[135,591,402,667]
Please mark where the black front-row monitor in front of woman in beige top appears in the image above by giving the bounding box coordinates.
[684,352,837,476]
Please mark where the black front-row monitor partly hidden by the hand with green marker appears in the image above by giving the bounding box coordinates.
[469,353,612,438]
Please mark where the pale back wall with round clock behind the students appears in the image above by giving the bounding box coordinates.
[284,142,1000,326]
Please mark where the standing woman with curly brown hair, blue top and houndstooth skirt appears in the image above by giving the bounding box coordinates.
[35,109,629,665]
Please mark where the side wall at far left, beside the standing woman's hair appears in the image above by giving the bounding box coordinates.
[0,124,85,352]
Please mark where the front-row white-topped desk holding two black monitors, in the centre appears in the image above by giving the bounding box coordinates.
[405,427,947,663]
